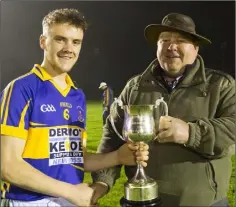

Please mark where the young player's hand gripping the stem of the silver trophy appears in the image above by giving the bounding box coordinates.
[117,142,149,167]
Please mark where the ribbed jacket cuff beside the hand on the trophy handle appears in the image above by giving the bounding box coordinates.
[185,123,201,149]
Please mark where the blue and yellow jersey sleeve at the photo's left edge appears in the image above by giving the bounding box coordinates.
[0,80,33,139]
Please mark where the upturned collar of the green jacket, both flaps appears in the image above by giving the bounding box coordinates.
[140,55,206,87]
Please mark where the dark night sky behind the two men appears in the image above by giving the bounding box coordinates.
[1,1,235,100]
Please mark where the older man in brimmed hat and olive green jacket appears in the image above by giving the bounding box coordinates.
[90,13,235,206]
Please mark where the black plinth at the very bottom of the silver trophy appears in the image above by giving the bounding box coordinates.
[120,197,162,207]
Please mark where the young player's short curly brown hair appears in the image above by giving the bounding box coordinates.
[42,8,88,32]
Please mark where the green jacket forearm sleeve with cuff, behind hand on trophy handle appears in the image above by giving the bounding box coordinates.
[186,117,235,159]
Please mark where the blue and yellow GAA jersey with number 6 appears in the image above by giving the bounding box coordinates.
[0,65,86,201]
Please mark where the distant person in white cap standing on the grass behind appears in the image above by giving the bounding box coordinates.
[99,82,114,125]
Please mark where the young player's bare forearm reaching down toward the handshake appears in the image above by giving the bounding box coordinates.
[1,160,73,199]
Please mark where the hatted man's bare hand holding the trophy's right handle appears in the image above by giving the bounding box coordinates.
[157,116,189,144]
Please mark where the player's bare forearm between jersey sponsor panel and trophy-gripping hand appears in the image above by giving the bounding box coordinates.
[84,151,120,172]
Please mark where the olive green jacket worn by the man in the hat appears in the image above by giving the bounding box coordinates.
[92,56,235,206]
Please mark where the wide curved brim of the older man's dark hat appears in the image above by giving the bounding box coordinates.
[144,24,211,45]
